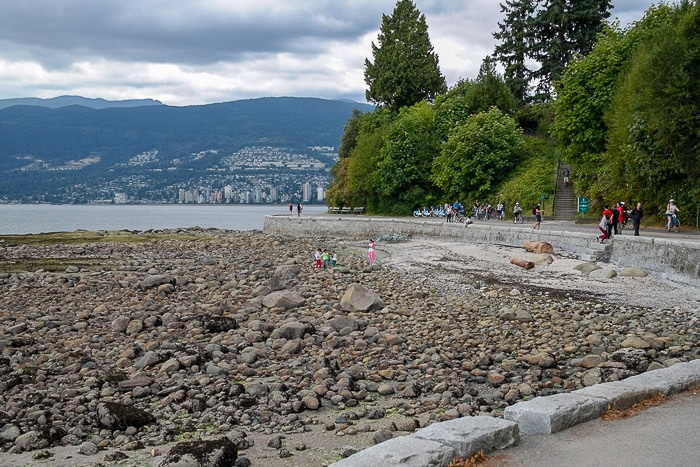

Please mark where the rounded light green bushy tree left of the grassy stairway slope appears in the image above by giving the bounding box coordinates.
[432,108,524,203]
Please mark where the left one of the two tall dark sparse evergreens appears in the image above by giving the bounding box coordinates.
[493,0,535,102]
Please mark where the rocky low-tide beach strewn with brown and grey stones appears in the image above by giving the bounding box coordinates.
[0,229,700,467]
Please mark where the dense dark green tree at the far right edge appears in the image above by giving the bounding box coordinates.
[606,1,700,209]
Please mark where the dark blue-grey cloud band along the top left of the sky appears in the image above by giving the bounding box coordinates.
[0,0,393,66]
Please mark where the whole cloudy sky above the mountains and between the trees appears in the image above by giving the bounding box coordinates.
[0,0,655,106]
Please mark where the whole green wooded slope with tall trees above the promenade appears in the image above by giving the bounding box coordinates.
[328,0,700,221]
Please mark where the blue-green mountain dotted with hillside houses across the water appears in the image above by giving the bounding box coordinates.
[0,96,373,203]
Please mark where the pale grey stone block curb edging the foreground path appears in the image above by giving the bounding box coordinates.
[329,359,700,467]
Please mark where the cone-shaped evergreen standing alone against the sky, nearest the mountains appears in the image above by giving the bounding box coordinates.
[365,0,447,112]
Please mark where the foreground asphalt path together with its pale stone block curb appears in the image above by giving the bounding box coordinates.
[331,360,700,467]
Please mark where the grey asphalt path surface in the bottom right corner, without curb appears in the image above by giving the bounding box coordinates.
[481,388,700,467]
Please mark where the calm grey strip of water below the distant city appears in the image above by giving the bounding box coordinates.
[0,204,327,234]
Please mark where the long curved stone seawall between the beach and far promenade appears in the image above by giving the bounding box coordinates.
[263,216,700,287]
